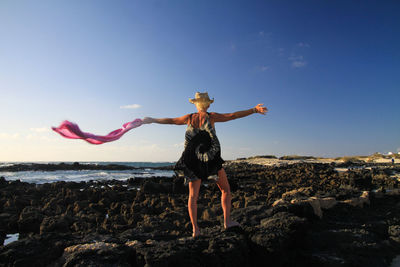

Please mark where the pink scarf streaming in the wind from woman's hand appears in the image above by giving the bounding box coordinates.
[51,119,143,145]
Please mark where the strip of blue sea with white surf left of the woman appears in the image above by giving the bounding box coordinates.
[0,161,175,184]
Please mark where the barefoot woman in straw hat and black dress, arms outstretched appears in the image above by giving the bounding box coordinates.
[143,92,268,237]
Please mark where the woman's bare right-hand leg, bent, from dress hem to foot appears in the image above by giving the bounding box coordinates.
[217,168,239,229]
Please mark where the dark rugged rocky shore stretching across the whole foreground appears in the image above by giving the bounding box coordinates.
[0,161,400,266]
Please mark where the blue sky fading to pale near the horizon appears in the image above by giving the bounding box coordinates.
[0,0,400,161]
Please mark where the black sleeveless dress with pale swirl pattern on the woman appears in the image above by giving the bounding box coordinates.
[174,113,224,184]
